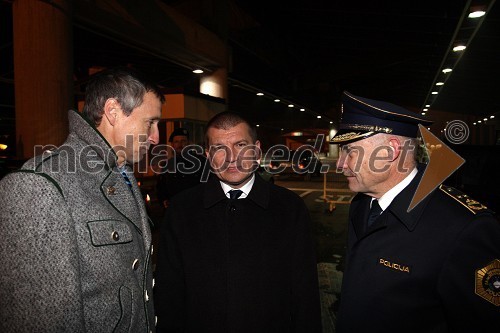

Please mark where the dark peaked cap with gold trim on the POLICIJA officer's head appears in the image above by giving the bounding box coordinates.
[330,91,432,144]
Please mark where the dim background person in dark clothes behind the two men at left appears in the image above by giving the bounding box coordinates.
[156,128,207,208]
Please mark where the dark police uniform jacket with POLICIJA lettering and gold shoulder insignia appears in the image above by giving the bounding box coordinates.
[337,173,500,333]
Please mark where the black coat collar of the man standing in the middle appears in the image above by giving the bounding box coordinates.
[203,173,270,209]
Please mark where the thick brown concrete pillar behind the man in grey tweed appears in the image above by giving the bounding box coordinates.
[12,0,74,158]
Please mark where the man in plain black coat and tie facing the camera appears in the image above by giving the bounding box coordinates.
[155,112,321,333]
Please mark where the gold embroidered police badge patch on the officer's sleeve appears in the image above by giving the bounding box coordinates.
[476,259,500,306]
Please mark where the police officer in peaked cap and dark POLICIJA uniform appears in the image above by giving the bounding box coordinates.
[330,92,500,332]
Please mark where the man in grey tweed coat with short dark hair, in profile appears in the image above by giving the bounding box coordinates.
[0,69,164,333]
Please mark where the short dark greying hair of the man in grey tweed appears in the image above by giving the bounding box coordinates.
[83,67,165,126]
